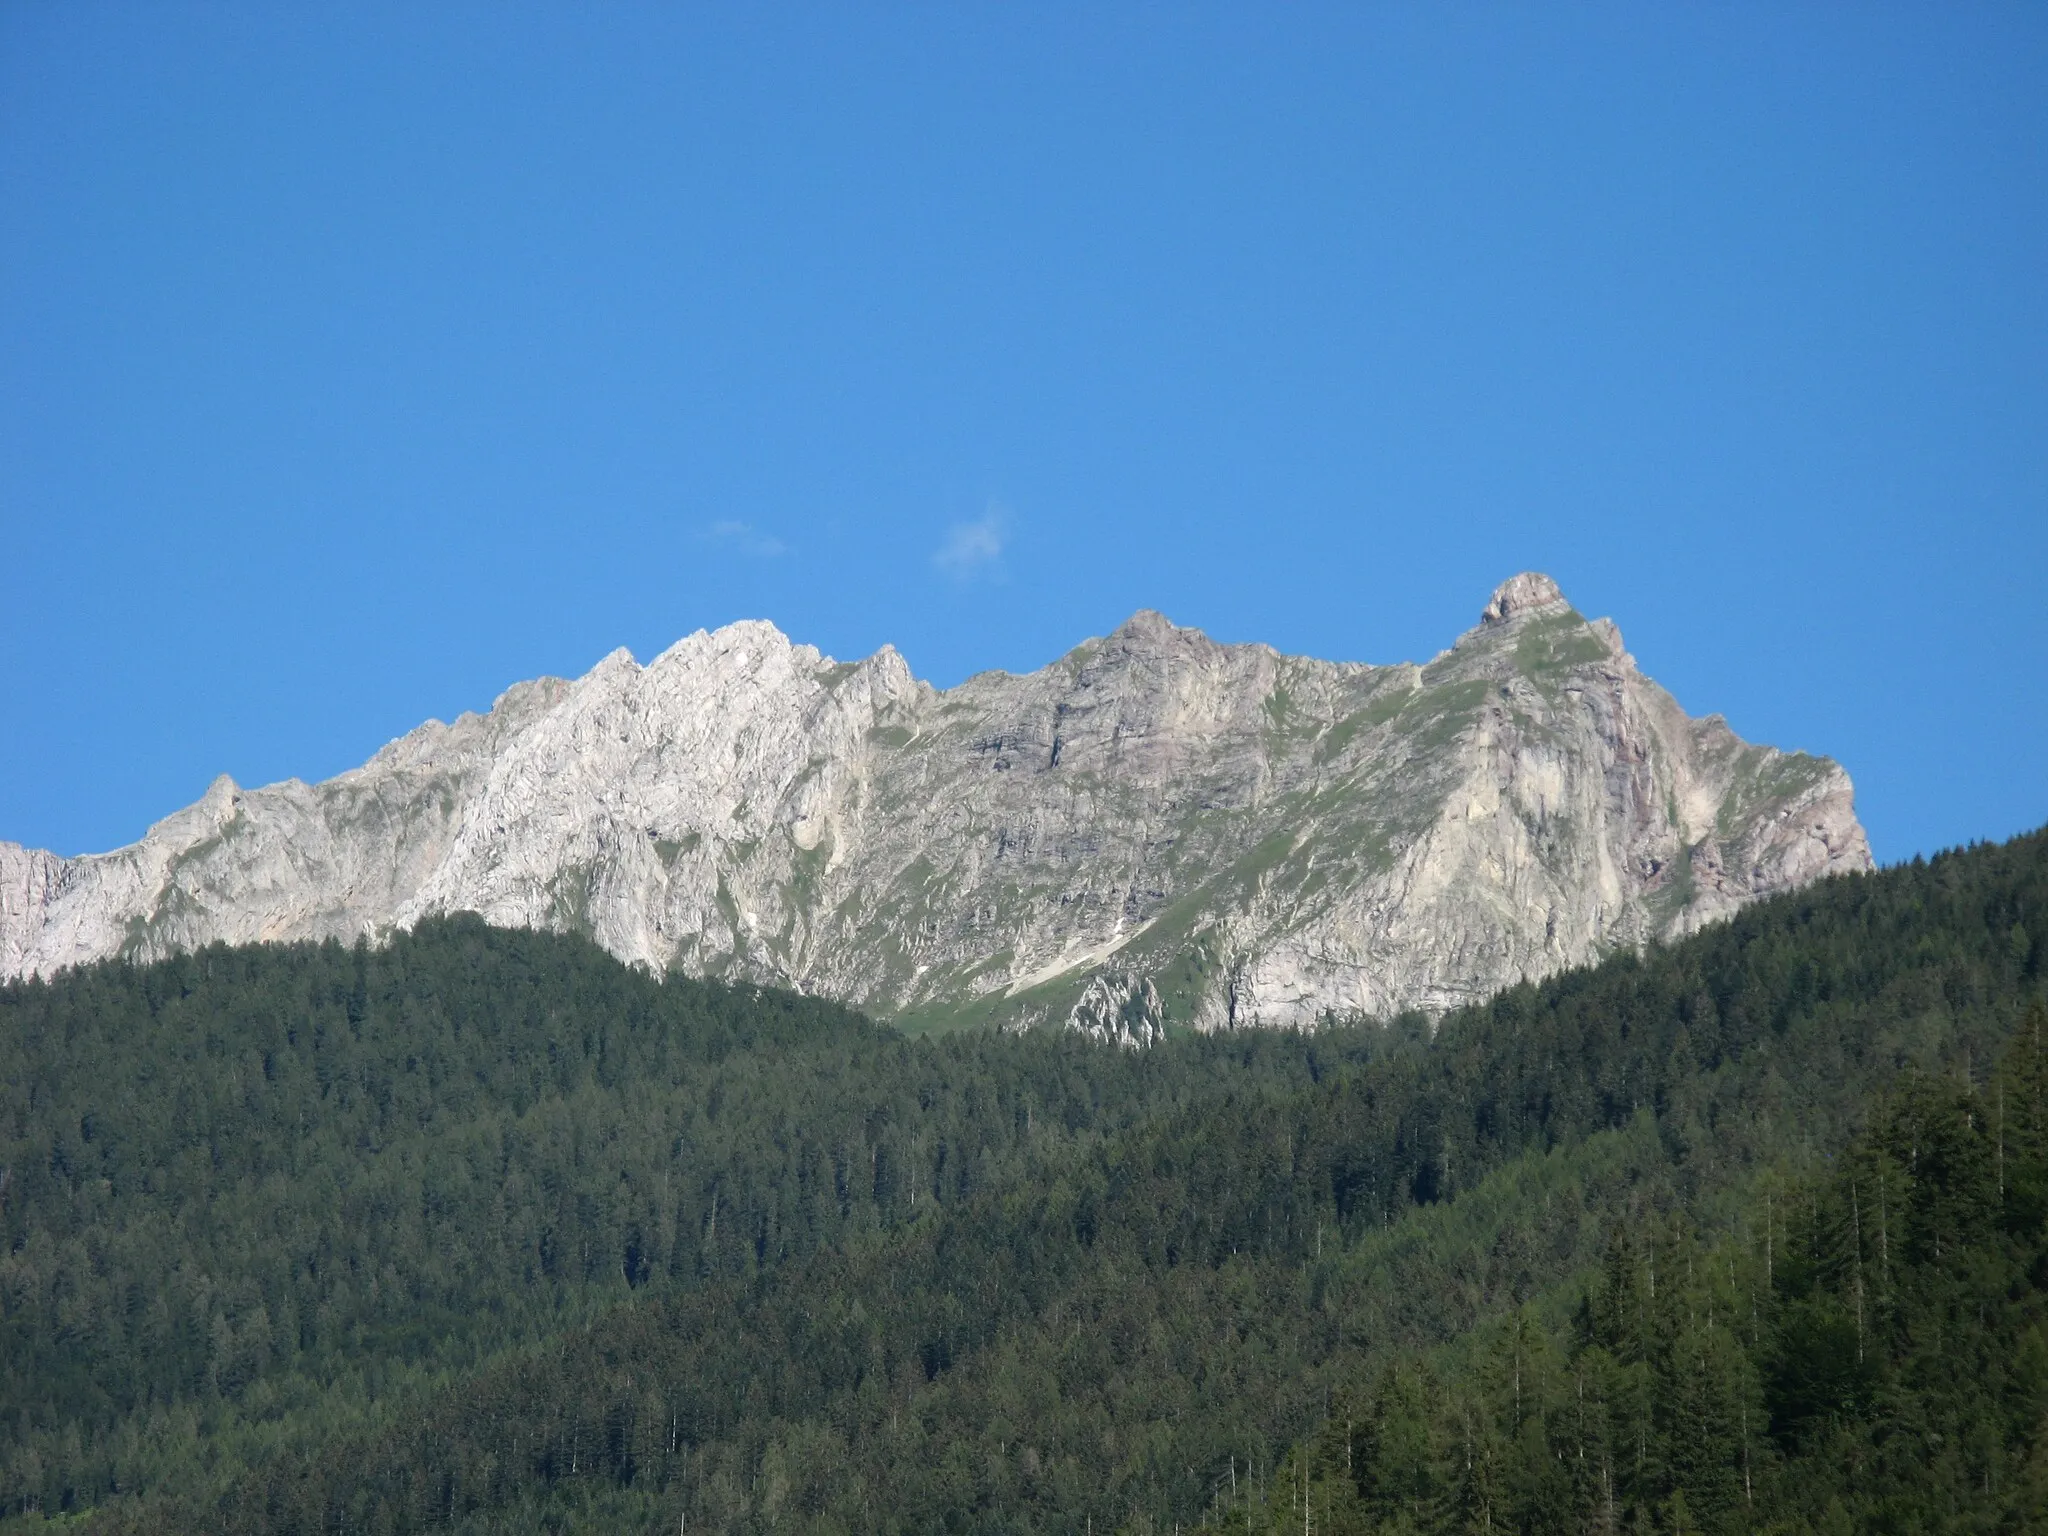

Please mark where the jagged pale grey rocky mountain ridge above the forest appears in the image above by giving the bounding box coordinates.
[0,575,1870,1040]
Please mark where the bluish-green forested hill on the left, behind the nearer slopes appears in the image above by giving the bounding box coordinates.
[0,918,1374,1511]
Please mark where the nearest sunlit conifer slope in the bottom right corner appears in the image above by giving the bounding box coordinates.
[1204,1004,2048,1536]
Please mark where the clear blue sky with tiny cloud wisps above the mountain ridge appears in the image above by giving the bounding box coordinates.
[0,0,2048,860]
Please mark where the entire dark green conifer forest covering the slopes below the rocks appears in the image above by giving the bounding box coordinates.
[0,834,2048,1532]
